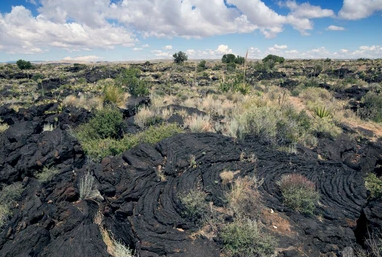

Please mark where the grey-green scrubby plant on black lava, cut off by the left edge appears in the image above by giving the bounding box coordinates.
[0,183,23,228]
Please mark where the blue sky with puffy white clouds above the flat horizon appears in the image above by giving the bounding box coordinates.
[0,0,382,62]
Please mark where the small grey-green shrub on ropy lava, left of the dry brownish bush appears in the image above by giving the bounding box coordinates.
[178,189,208,223]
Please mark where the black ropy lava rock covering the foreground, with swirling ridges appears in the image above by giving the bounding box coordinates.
[0,105,382,257]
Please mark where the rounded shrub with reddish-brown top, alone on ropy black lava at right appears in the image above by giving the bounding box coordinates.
[279,174,320,214]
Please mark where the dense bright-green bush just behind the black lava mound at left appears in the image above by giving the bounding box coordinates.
[76,105,123,141]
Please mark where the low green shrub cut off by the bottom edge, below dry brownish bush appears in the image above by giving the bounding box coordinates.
[220,219,277,257]
